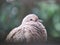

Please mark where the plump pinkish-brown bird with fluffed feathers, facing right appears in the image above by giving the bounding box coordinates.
[6,14,47,43]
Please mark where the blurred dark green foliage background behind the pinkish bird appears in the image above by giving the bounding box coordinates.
[0,0,60,42]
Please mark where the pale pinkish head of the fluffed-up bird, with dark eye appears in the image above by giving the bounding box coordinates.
[22,14,42,23]
